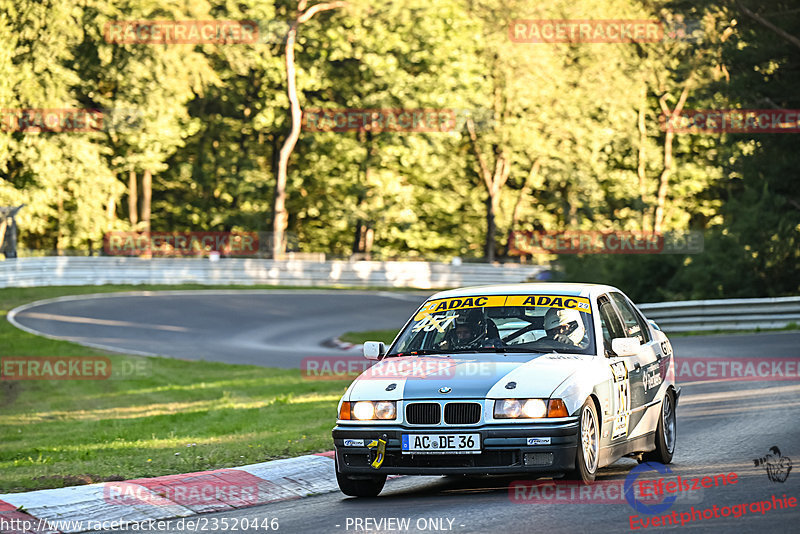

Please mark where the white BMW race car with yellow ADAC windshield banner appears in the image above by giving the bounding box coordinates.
[333,283,680,497]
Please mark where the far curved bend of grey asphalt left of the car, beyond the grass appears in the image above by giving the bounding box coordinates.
[7,290,430,368]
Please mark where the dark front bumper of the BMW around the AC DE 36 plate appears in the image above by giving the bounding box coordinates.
[333,418,579,475]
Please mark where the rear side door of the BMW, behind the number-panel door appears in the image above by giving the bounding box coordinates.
[609,292,662,438]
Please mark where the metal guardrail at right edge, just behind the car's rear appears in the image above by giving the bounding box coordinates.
[639,297,800,332]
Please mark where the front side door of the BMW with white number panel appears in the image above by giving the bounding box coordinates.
[597,295,633,442]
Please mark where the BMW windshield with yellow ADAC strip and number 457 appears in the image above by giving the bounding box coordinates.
[389,295,595,356]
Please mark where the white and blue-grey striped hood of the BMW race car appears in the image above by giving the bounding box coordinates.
[349,353,591,401]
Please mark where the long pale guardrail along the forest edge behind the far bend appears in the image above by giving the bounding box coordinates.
[0,256,544,289]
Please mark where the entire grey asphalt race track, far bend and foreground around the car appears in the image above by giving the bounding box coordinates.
[7,292,800,534]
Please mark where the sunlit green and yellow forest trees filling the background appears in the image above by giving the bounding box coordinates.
[0,0,800,300]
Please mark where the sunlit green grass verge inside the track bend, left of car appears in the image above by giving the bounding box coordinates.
[0,285,349,493]
